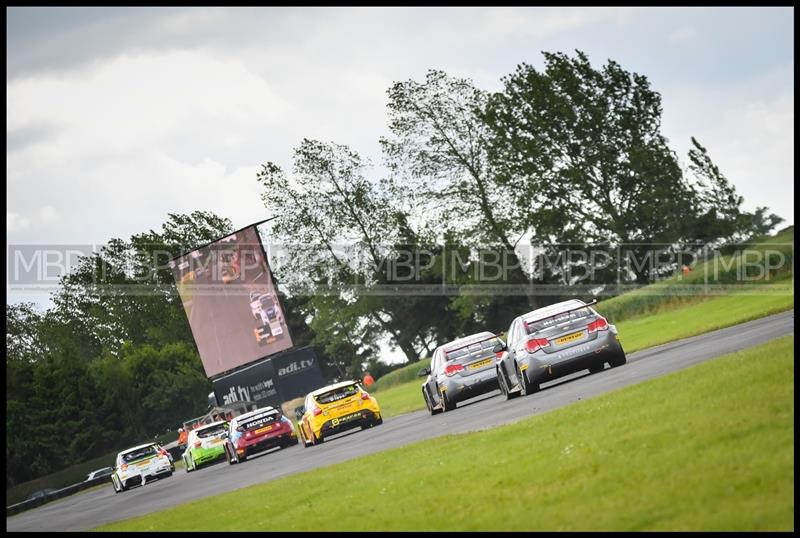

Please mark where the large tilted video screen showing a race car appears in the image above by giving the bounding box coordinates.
[169,225,292,377]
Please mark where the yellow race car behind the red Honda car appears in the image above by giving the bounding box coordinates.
[297,381,383,447]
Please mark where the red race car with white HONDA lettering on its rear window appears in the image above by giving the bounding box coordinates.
[224,406,297,464]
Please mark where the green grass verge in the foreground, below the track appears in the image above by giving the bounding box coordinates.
[94,336,794,531]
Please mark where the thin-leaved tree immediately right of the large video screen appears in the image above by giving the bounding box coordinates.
[258,139,456,360]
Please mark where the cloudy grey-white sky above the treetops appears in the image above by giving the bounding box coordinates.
[6,8,794,301]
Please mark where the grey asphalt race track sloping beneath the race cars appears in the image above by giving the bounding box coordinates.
[6,304,794,531]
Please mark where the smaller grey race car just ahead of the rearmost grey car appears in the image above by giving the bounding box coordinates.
[418,331,500,415]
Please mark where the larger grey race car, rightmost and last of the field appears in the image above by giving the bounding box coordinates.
[494,299,627,399]
